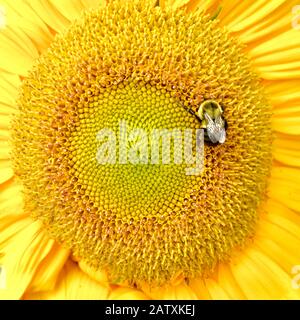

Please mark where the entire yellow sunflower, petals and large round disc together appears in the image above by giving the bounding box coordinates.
[0,0,300,299]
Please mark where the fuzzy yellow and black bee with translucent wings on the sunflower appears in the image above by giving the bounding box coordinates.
[182,100,227,144]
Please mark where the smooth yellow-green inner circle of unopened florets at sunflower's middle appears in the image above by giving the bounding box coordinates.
[65,82,203,220]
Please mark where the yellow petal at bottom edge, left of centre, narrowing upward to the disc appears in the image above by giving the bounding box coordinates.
[23,260,108,300]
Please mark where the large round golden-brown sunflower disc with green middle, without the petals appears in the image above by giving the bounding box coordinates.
[13,1,271,284]
